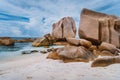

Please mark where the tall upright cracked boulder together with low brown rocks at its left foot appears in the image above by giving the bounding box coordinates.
[32,17,76,47]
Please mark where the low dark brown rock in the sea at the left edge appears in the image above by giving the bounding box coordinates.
[0,37,15,46]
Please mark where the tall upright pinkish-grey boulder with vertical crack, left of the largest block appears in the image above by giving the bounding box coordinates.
[52,17,76,40]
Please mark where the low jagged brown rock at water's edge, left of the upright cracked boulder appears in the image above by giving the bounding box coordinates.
[32,34,55,47]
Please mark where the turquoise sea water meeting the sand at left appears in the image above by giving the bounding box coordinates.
[0,37,32,60]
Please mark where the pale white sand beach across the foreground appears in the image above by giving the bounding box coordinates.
[0,53,120,80]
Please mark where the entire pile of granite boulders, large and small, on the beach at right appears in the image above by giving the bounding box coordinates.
[32,9,120,67]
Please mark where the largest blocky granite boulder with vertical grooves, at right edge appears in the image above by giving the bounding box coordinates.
[78,9,120,47]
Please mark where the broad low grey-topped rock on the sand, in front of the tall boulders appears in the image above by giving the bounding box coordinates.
[57,46,95,61]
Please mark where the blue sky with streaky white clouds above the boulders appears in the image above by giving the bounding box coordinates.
[0,0,120,37]
